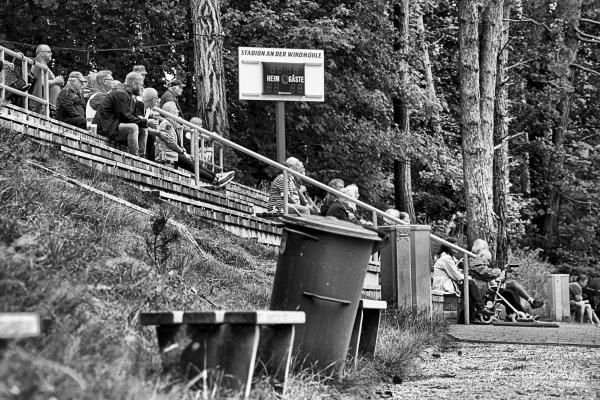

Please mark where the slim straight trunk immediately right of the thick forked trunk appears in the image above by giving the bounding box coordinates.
[493,4,510,266]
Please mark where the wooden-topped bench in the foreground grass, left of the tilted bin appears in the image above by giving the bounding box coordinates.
[140,310,305,399]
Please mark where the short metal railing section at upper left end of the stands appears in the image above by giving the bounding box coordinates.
[0,46,50,117]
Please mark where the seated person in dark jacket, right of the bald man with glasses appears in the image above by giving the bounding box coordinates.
[56,71,87,129]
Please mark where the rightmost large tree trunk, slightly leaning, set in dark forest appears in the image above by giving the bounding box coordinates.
[544,0,582,238]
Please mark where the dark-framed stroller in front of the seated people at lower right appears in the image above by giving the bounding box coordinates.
[478,264,537,324]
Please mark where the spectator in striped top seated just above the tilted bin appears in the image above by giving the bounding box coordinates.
[267,157,310,214]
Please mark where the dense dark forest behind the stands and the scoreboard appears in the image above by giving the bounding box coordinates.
[0,0,600,274]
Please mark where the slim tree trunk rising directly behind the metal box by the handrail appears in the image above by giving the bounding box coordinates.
[392,0,416,222]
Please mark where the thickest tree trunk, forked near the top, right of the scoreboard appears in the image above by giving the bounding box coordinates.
[458,0,501,250]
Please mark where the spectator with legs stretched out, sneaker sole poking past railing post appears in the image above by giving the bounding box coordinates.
[154,102,235,187]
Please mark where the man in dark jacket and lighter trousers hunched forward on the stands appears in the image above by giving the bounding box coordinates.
[93,72,158,157]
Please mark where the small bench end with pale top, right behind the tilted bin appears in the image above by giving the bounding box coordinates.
[348,299,387,367]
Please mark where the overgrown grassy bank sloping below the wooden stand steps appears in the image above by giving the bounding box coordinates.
[0,128,444,400]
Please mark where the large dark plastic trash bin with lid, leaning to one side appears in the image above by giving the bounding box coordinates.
[270,216,381,374]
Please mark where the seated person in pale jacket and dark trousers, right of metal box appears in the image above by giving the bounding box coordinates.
[431,238,494,321]
